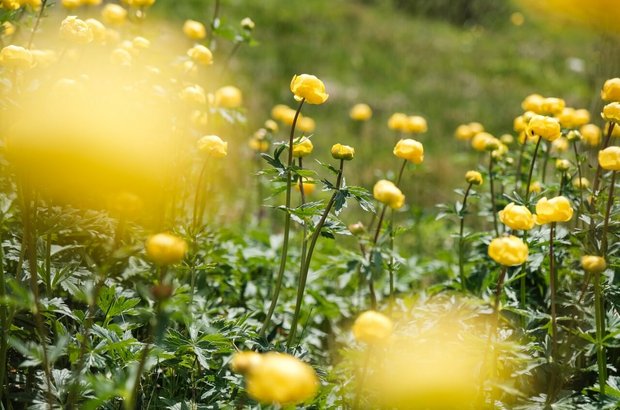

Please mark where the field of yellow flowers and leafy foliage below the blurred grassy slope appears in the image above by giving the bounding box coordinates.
[0,0,620,410]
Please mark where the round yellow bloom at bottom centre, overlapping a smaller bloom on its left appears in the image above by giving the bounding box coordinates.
[246,352,319,406]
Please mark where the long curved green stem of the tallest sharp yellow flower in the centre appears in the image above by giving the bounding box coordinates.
[259,99,305,337]
